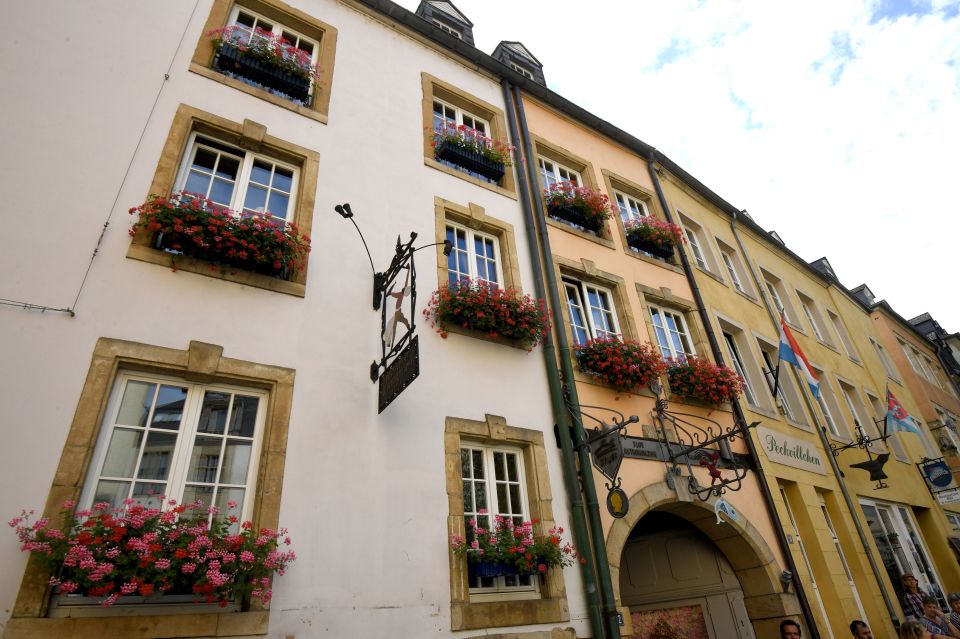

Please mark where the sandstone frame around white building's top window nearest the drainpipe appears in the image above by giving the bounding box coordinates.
[420,72,520,200]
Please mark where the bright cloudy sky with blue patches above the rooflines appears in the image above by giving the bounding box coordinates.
[400,0,960,332]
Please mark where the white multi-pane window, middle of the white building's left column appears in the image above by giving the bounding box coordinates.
[176,133,298,222]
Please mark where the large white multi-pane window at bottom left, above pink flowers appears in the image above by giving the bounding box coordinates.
[81,374,266,528]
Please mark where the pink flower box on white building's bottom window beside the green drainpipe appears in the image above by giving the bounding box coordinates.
[450,510,587,577]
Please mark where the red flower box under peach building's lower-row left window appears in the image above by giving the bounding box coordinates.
[575,339,667,392]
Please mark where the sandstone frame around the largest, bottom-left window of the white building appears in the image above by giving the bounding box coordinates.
[4,337,295,639]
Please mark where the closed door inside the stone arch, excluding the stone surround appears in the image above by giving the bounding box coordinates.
[620,511,755,639]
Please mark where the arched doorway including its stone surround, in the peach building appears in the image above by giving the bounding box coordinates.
[607,482,808,639]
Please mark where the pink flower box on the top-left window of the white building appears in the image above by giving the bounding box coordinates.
[207,25,319,103]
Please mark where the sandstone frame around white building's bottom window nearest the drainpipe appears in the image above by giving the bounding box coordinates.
[444,414,570,631]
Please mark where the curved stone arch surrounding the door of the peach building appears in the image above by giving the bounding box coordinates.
[606,481,805,637]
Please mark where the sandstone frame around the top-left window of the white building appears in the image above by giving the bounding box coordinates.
[190,0,337,124]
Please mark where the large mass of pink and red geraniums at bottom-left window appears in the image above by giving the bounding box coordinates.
[9,499,296,606]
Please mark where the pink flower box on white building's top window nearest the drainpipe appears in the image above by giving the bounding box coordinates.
[433,121,516,182]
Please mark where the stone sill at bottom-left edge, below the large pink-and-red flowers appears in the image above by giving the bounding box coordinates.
[3,610,270,639]
